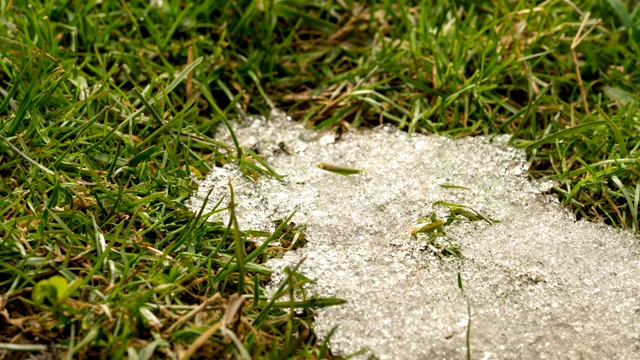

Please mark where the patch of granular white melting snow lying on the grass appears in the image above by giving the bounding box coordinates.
[190,113,640,359]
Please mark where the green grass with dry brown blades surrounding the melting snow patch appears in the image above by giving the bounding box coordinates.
[0,0,640,359]
